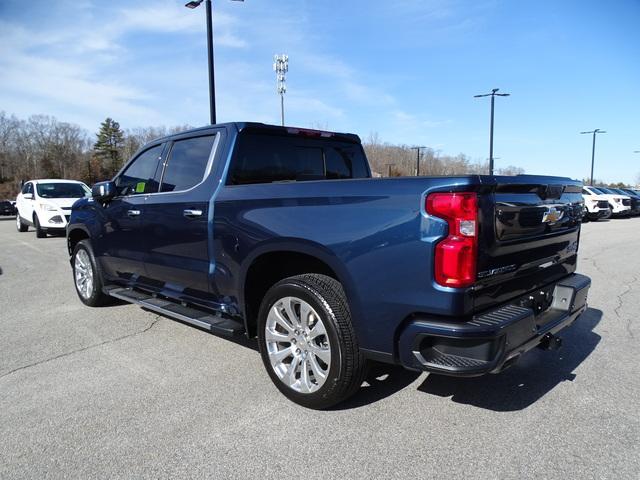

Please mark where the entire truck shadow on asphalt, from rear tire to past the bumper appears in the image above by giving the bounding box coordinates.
[334,308,602,412]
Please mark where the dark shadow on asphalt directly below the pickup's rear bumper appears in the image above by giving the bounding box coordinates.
[418,308,602,412]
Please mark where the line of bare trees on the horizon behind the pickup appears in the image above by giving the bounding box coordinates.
[0,111,636,199]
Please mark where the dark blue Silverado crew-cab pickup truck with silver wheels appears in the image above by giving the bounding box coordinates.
[67,123,590,408]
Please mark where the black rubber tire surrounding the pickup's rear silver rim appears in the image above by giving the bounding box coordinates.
[258,274,365,409]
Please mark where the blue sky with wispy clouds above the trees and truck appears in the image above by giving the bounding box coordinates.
[0,0,640,183]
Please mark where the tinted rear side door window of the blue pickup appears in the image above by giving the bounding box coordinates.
[160,135,215,192]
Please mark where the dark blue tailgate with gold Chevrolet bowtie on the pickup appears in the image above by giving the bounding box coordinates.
[473,175,583,311]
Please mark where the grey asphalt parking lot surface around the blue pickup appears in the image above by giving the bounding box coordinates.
[0,218,640,479]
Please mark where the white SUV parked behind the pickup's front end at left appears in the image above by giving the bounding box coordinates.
[16,179,91,238]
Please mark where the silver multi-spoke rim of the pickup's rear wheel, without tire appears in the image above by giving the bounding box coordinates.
[265,297,331,393]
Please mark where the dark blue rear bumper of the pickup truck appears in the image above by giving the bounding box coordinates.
[398,274,591,376]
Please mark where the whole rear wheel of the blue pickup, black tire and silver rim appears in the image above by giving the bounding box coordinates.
[258,274,364,409]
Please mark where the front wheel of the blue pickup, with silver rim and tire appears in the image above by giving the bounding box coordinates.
[71,240,111,307]
